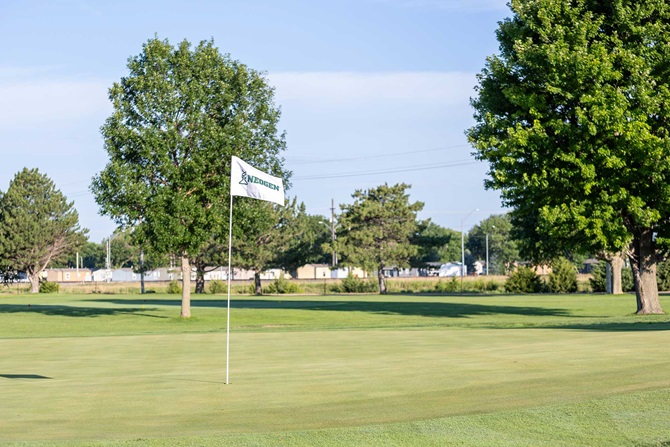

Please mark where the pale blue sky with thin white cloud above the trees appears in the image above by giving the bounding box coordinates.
[0,0,509,242]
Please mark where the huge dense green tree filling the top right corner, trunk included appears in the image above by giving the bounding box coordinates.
[468,0,670,314]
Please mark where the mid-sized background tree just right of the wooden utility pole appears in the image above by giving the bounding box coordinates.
[338,183,423,294]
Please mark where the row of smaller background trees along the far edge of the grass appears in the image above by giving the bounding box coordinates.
[0,168,518,294]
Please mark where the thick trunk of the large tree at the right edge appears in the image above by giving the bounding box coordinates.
[629,229,663,315]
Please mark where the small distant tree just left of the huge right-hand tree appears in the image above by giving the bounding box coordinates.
[467,214,521,275]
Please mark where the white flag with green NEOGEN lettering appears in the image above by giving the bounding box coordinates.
[230,157,284,206]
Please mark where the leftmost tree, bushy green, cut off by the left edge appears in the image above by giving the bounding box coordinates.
[0,168,87,293]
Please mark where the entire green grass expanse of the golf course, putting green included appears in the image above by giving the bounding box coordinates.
[0,295,670,446]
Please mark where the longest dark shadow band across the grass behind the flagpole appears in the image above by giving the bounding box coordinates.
[89,299,571,318]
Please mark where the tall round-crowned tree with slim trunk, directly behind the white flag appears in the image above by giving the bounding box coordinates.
[92,38,288,317]
